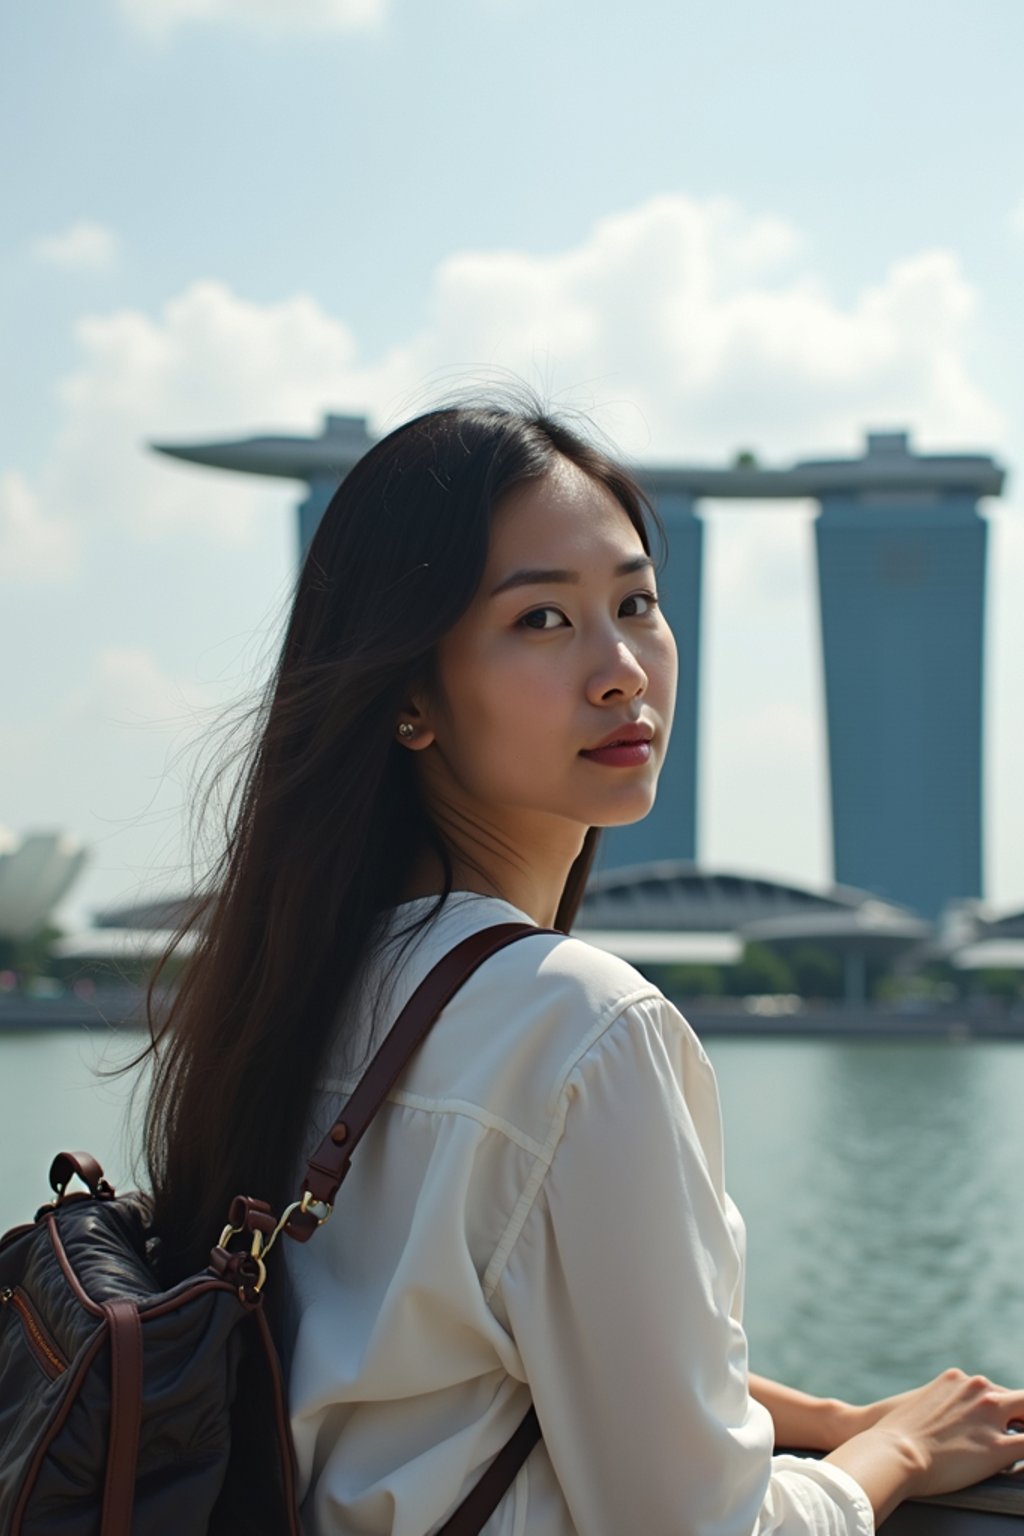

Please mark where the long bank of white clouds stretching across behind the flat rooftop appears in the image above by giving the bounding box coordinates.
[23,197,1003,568]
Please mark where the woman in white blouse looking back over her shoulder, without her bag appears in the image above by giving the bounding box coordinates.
[149,407,1024,1536]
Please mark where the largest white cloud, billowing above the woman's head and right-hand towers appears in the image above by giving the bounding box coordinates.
[380,197,1003,458]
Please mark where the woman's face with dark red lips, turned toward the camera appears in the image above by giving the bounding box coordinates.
[410,459,676,866]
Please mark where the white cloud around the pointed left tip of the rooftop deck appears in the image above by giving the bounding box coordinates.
[49,281,363,547]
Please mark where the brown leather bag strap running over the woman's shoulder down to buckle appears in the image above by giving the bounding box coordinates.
[296,923,554,1216]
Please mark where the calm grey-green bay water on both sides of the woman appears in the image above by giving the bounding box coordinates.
[0,1032,1024,1401]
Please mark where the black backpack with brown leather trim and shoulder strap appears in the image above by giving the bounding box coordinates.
[0,923,543,1536]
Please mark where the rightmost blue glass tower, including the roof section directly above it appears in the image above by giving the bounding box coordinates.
[815,433,1001,917]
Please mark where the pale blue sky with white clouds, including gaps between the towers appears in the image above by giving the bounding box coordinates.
[0,0,1024,928]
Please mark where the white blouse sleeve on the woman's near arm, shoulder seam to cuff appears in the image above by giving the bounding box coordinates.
[494,998,874,1536]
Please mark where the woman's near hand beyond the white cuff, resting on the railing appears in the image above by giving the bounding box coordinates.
[827,1370,1024,1522]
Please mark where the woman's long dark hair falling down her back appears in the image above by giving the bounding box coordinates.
[146,406,649,1279]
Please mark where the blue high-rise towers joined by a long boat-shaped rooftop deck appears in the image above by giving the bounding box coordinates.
[157,416,1004,919]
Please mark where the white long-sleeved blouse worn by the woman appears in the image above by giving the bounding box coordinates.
[284,892,874,1536]
